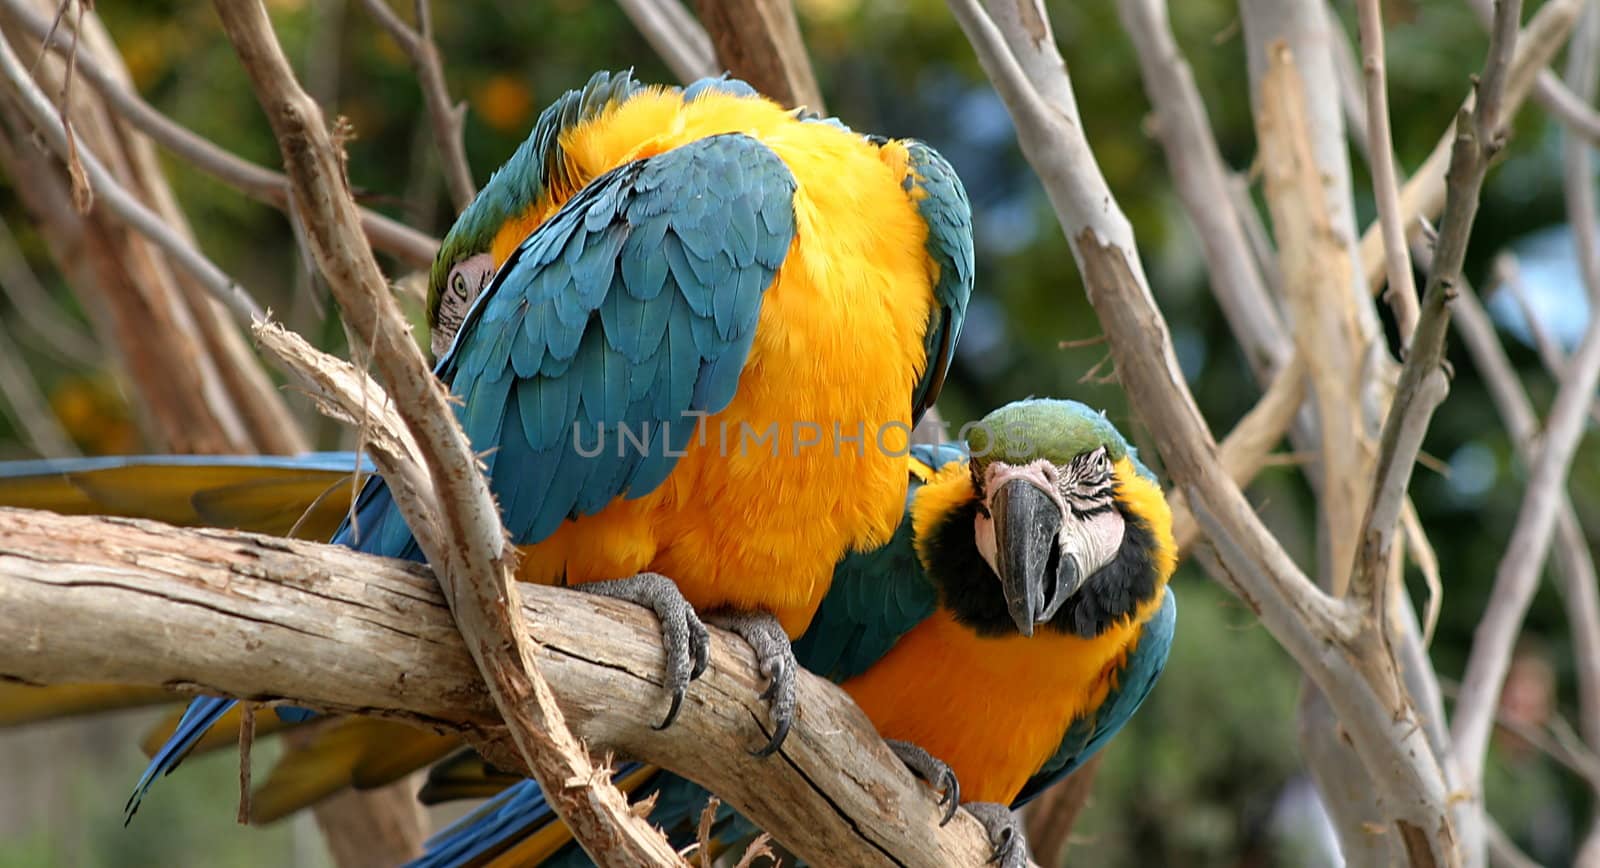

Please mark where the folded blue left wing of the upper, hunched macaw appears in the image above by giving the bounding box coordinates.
[438,135,795,543]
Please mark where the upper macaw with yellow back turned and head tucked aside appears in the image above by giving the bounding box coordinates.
[116,72,973,817]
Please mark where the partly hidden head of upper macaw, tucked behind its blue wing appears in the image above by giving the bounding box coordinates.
[427,70,643,359]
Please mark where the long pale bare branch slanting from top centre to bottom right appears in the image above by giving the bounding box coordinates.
[950,0,1461,865]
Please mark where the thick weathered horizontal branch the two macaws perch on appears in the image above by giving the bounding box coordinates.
[0,509,989,868]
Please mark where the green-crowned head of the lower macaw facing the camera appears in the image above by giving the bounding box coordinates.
[966,400,1174,636]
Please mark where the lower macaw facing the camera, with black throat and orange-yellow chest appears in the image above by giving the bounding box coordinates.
[393,400,1178,868]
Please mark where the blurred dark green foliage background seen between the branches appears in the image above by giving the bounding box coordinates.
[0,0,1600,868]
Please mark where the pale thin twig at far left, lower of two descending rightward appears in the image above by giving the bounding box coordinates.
[0,28,262,323]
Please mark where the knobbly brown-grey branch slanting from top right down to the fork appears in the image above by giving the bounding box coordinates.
[1350,0,1522,611]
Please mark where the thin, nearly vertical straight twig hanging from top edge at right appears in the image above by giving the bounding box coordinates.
[1355,0,1418,348]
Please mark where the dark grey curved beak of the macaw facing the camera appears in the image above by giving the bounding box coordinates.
[989,479,1080,636]
